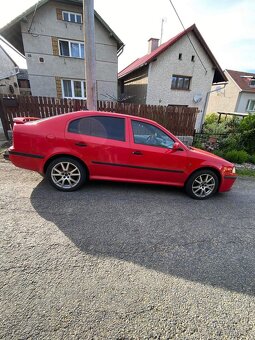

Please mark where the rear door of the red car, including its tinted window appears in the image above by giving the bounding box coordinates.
[66,115,129,180]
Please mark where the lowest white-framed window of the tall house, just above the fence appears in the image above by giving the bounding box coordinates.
[62,79,86,99]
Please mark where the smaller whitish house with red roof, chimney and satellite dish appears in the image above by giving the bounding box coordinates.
[118,25,227,129]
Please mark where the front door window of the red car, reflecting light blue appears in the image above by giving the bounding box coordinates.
[132,120,174,149]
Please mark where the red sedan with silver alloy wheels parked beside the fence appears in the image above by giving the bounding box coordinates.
[5,111,236,199]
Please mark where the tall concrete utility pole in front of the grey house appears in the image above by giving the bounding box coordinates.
[83,0,97,111]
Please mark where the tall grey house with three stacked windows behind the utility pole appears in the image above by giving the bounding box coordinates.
[0,0,124,100]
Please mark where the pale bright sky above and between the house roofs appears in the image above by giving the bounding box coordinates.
[0,0,255,73]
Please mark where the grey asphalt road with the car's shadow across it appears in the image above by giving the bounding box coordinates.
[0,161,255,340]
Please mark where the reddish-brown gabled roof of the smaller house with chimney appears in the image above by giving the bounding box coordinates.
[118,24,227,82]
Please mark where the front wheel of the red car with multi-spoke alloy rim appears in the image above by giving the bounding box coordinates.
[185,169,219,200]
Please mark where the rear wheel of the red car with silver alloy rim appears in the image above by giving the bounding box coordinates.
[46,157,87,191]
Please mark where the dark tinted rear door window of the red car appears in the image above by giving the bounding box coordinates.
[68,116,125,141]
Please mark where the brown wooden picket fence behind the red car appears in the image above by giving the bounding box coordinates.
[0,96,197,138]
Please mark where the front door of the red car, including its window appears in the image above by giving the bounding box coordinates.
[128,119,187,185]
